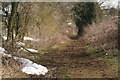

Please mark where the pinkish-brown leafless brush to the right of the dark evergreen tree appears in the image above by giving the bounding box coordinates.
[83,17,118,51]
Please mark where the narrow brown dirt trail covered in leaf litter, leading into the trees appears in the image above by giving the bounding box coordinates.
[32,39,116,78]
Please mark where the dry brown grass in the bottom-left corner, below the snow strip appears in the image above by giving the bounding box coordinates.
[2,57,29,78]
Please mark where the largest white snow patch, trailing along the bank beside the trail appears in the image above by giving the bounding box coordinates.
[0,47,48,75]
